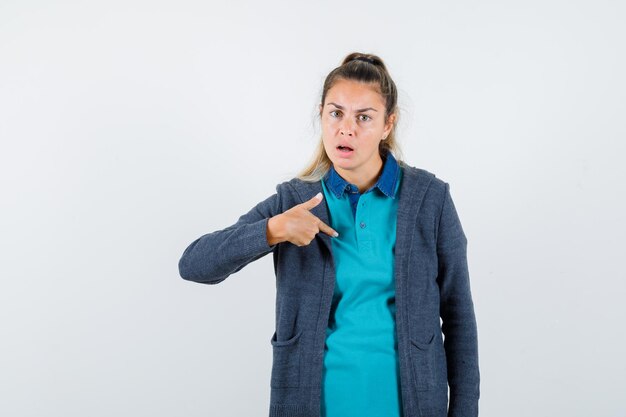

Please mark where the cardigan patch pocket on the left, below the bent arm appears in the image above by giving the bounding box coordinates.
[270,330,302,388]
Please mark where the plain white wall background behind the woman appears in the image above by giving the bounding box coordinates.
[0,0,626,417]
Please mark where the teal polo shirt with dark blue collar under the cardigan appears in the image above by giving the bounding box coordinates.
[321,153,402,417]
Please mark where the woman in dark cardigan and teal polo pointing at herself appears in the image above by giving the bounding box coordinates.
[179,53,480,417]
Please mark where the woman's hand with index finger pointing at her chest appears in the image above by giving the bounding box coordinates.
[267,193,339,246]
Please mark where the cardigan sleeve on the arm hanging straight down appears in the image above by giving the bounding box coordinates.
[437,183,480,417]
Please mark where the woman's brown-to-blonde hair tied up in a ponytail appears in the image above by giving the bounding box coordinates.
[297,52,402,182]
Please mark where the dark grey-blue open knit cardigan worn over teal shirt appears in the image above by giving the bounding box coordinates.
[178,161,480,417]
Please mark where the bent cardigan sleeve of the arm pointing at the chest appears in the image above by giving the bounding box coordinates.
[178,186,280,284]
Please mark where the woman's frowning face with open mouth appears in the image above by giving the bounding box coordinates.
[320,80,394,181]
